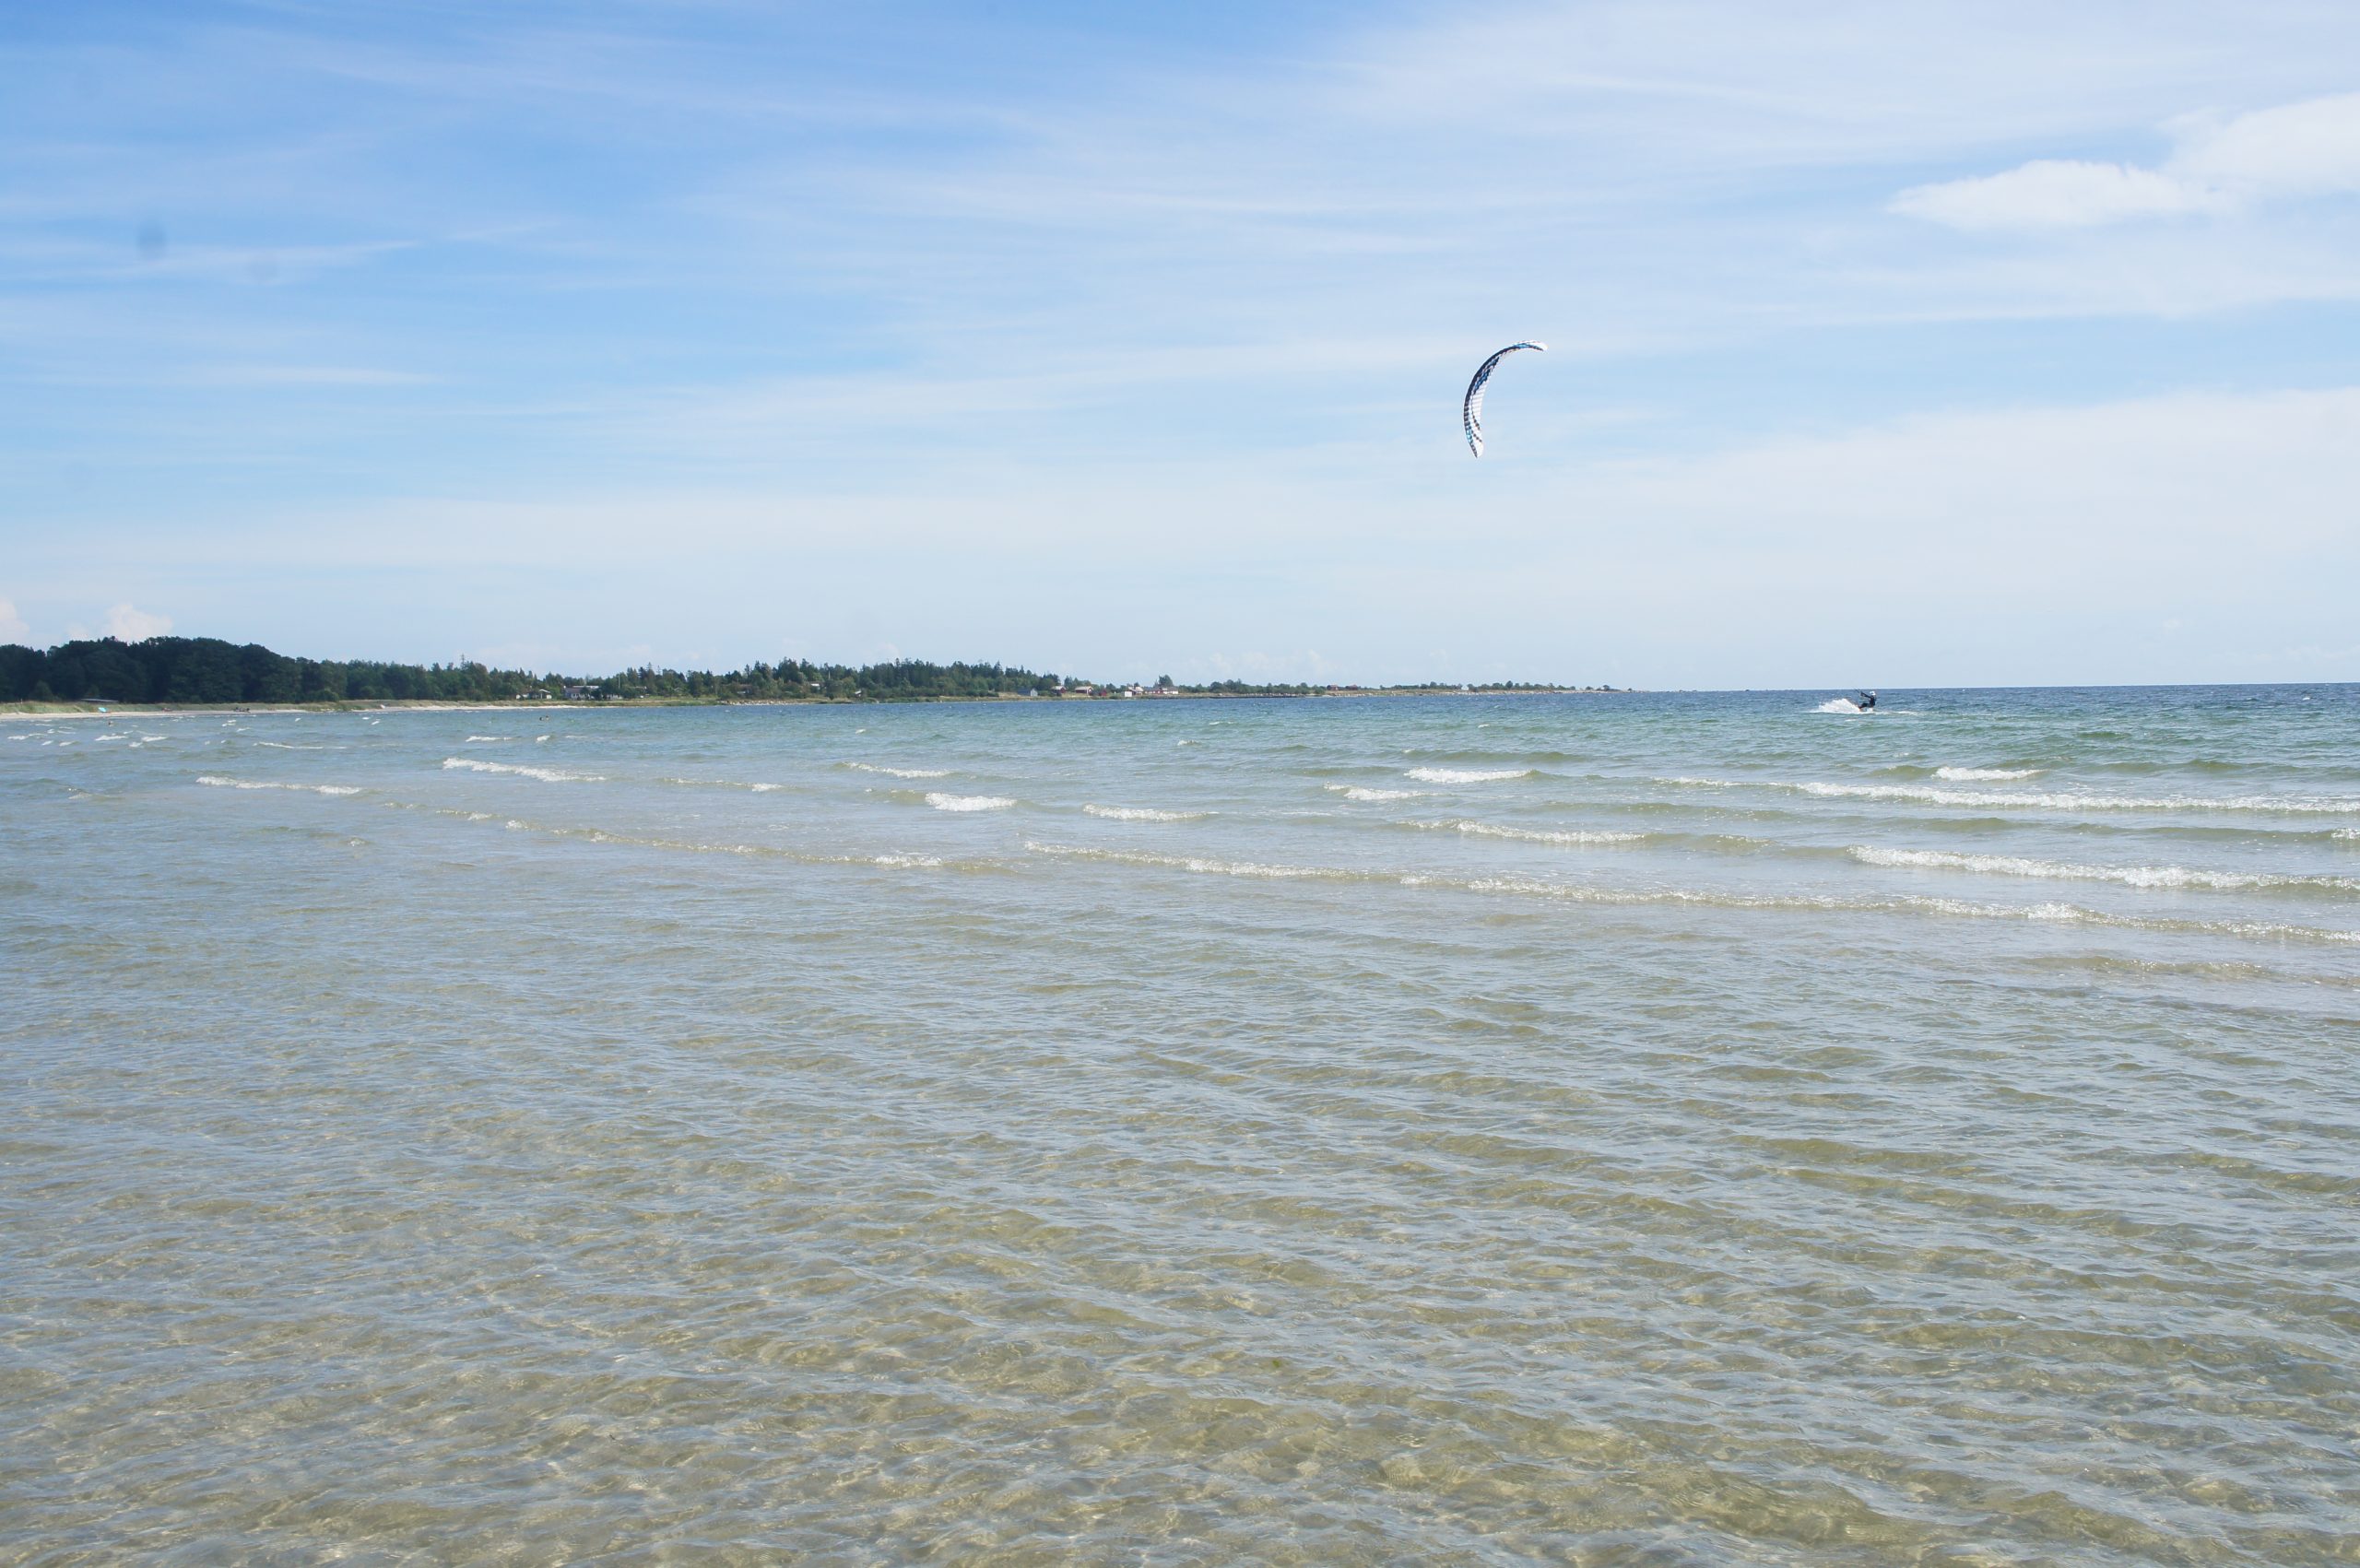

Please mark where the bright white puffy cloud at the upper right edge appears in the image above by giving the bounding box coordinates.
[1891,92,2360,229]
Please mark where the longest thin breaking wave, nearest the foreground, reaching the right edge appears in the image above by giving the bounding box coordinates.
[1024,841,2360,942]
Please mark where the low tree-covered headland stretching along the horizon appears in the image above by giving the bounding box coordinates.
[0,638,1617,709]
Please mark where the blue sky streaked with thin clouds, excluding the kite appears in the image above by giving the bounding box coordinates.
[0,0,2360,690]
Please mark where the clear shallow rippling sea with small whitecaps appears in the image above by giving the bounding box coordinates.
[0,685,2360,1565]
